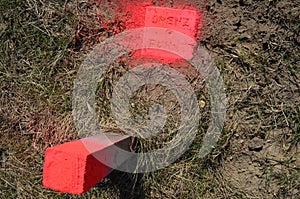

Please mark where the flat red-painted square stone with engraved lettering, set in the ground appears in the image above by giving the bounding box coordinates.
[133,6,200,63]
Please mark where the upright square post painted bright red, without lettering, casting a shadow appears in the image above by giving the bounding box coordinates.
[43,134,131,194]
